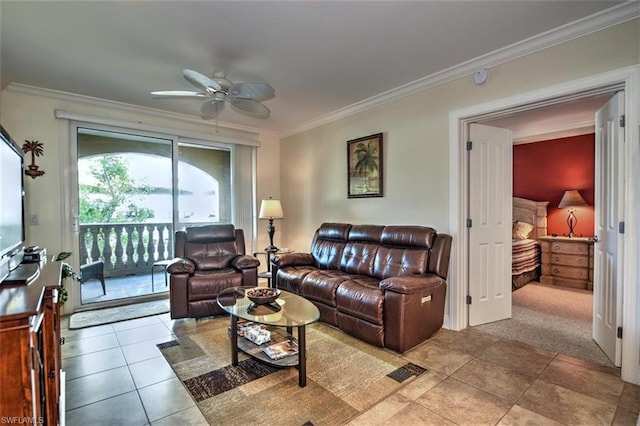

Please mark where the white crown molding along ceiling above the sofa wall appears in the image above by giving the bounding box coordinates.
[280,0,640,138]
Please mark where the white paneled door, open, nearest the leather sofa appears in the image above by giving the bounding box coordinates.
[467,124,513,326]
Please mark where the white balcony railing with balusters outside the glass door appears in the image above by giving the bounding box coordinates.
[80,222,173,277]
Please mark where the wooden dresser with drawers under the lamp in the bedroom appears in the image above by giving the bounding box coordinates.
[538,236,593,290]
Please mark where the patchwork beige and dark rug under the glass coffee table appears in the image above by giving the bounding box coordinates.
[158,317,427,426]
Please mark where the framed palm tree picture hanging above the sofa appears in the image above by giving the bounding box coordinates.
[347,133,383,198]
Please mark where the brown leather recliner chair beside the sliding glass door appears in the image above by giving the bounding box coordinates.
[167,225,260,319]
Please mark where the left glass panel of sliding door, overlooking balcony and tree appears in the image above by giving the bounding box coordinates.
[77,127,174,304]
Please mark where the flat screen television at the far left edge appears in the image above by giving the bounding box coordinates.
[0,126,25,283]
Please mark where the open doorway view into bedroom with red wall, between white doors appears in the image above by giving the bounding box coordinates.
[470,92,616,367]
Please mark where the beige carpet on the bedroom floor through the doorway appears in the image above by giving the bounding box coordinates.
[473,282,613,367]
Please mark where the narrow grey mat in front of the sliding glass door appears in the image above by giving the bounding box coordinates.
[69,299,169,330]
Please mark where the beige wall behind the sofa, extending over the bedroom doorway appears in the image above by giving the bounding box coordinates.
[280,19,640,251]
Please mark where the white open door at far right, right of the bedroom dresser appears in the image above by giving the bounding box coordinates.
[593,92,624,366]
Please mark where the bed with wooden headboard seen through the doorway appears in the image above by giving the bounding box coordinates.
[511,197,549,290]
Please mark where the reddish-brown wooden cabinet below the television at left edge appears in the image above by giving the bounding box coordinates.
[0,262,61,425]
